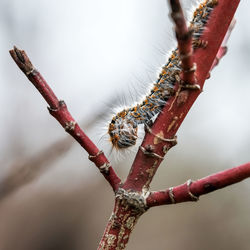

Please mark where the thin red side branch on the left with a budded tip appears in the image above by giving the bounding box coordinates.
[10,47,121,191]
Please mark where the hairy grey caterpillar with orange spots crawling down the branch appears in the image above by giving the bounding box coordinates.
[108,0,217,149]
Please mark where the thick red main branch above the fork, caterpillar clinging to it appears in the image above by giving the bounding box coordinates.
[123,0,239,192]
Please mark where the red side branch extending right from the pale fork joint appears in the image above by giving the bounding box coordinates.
[147,162,250,207]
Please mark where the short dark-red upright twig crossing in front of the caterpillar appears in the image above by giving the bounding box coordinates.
[170,0,196,84]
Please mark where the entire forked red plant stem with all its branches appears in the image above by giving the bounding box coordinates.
[10,0,243,250]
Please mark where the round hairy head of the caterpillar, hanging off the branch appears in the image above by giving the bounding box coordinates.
[108,111,138,149]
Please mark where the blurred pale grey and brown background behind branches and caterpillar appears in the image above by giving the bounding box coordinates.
[0,0,250,250]
